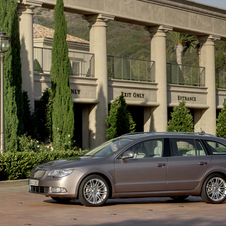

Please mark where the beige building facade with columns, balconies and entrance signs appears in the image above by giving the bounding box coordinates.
[18,0,226,148]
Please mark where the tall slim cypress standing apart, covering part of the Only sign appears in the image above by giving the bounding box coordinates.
[50,0,74,148]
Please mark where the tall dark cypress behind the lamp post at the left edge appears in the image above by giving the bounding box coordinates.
[0,0,24,151]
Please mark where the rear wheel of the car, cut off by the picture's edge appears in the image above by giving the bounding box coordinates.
[201,173,226,204]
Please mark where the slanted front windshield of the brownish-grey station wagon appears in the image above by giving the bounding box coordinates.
[84,138,133,157]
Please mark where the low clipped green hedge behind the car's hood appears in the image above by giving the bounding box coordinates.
[0,150,85,180]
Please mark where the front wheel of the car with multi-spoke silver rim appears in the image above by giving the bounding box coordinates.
[79,174,110,207]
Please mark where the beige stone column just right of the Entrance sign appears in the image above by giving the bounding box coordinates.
[195,35,220,135]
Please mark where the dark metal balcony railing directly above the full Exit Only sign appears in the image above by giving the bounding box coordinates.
[108,56,155,82]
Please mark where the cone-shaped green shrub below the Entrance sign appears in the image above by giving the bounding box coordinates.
[167,101,194,132]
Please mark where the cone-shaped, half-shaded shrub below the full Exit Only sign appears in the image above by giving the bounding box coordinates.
[106,95,136,139]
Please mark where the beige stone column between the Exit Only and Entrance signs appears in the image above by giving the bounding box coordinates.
[147,26,172,132]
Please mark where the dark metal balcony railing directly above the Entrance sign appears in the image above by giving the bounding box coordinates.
[167,63,205,86]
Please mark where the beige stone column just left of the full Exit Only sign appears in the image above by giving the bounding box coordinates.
[83,14,114,148]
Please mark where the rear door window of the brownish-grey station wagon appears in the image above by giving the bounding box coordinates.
[169,138,206,156]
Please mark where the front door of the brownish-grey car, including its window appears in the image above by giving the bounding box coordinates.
[115,139,167,193]
